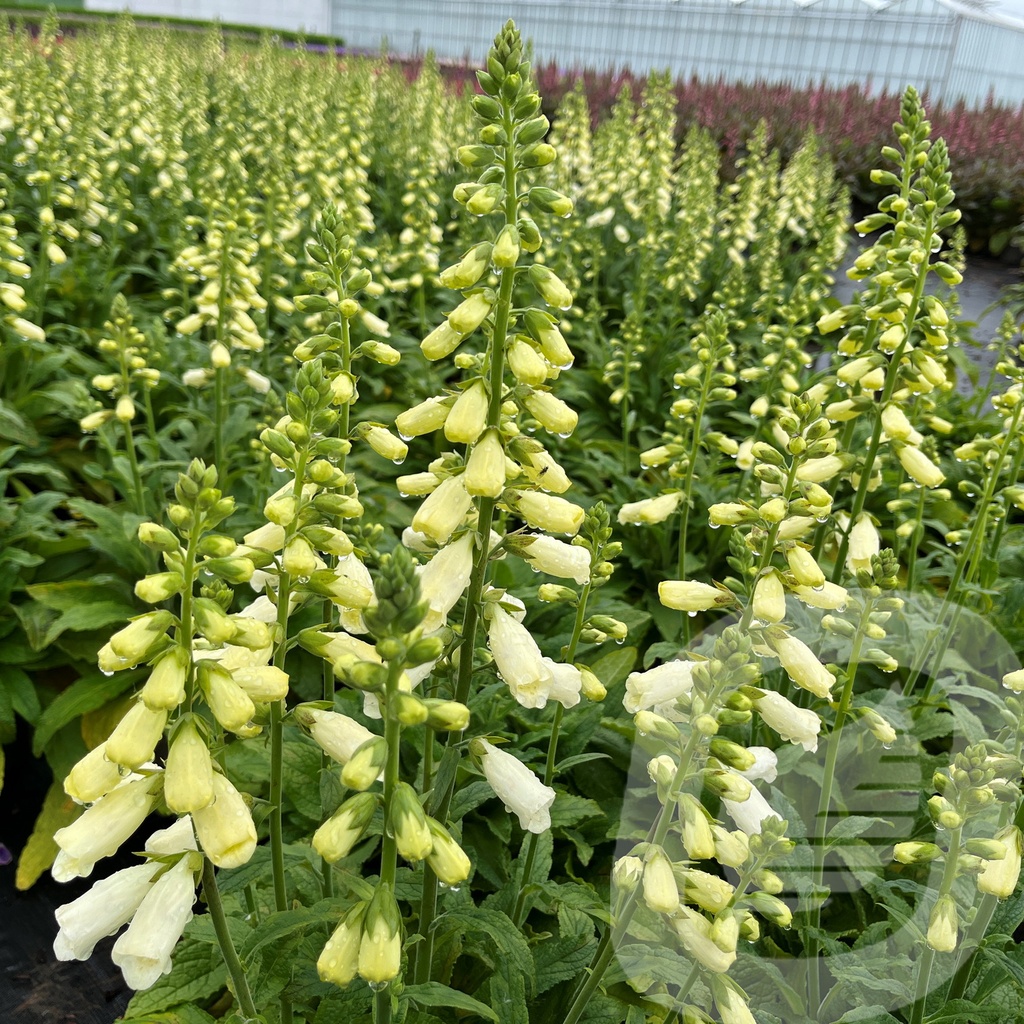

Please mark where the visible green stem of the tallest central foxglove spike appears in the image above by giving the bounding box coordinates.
[413,101,519,984]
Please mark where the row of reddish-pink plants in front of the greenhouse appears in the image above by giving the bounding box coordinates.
[430,63,1024,253]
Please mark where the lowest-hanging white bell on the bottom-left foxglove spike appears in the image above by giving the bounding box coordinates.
[111,853,202,991]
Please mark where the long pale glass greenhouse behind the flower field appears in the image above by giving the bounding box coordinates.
[86,0,1024,105]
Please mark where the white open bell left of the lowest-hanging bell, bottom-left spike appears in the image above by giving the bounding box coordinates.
[53,860,161,961]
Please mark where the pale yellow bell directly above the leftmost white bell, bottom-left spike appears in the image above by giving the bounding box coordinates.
[52,772,161,882]
